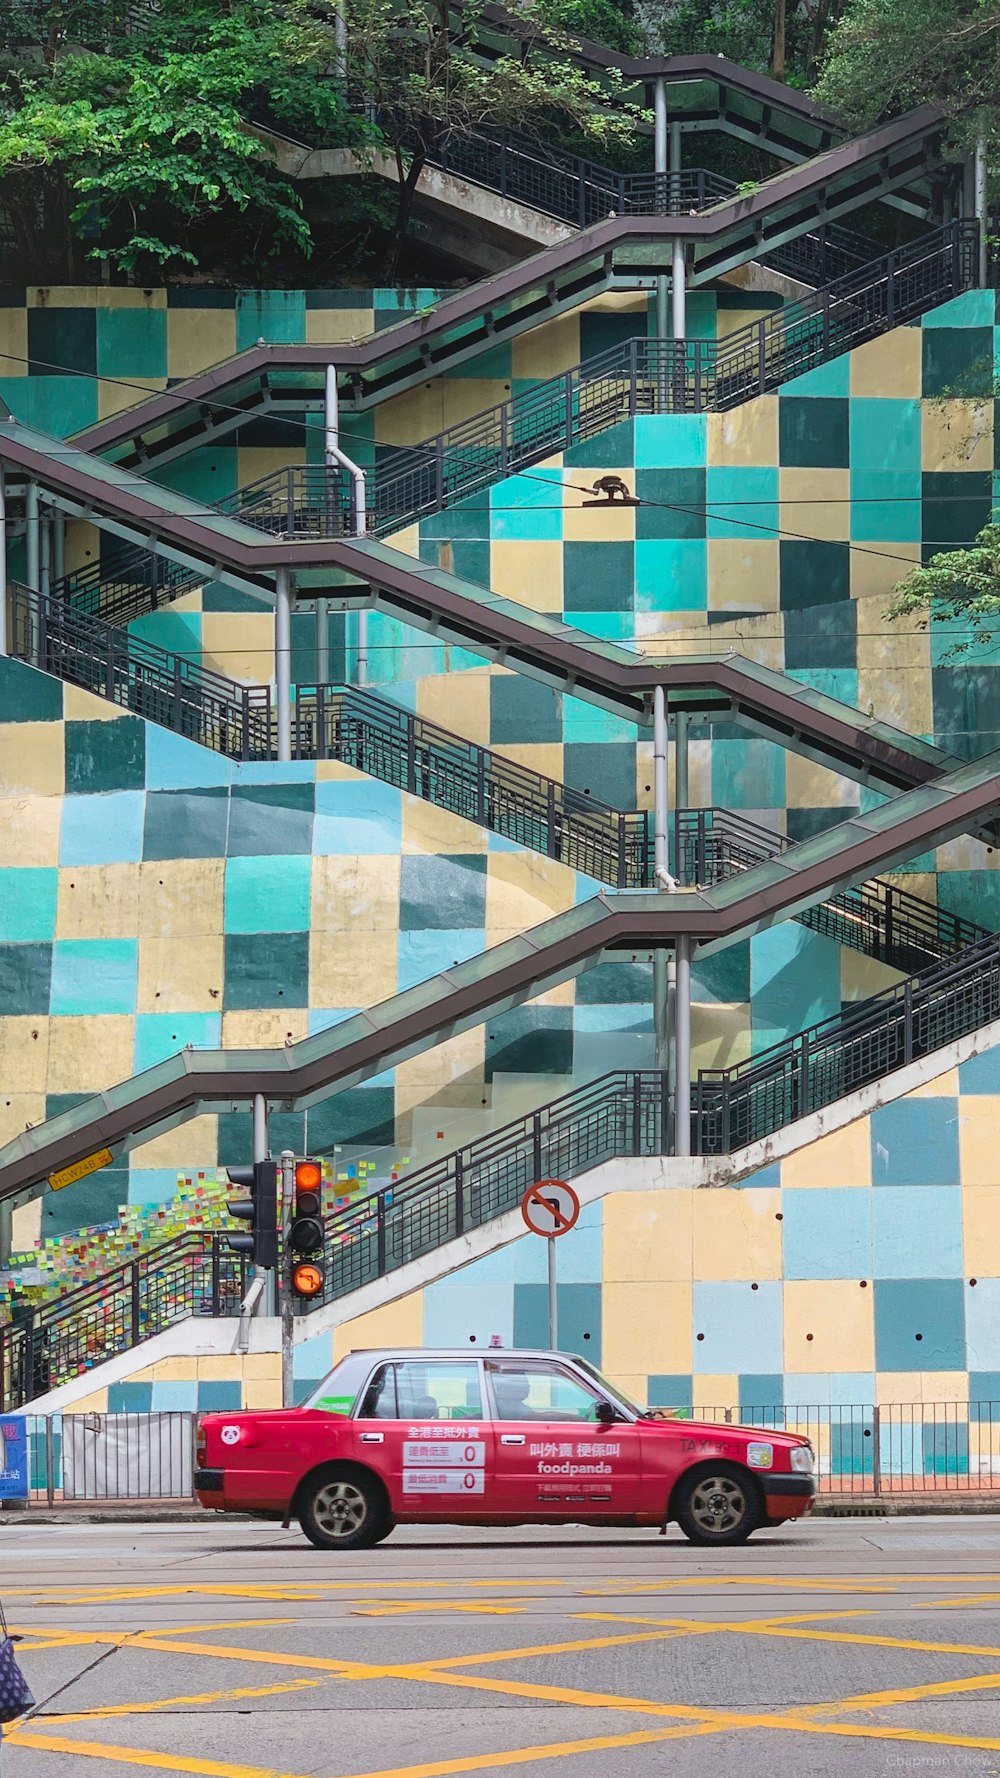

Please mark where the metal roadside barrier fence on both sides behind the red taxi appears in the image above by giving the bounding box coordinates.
[1,1401,1000,1506]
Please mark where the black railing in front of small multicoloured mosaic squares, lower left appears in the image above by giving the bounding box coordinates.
[0,1230,247,1414]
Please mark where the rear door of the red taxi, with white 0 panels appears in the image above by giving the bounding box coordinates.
[354,1358,496,1522]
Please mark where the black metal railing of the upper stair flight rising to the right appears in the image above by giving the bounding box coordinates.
[52,222,979,624]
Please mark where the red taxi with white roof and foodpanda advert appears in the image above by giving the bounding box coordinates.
[194,1350,815,1550]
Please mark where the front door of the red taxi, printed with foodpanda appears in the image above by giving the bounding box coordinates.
[486,1357,642,1518]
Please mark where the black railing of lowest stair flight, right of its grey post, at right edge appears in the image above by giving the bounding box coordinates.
[694,933,1000,1154]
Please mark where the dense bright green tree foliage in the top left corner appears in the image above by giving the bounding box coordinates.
[0,0,367,283]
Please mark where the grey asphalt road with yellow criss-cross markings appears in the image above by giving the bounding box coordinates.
[0,1517,1000,1778]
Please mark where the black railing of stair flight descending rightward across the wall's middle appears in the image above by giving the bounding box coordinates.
[11,583,984,971]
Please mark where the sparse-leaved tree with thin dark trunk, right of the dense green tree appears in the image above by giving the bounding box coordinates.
[347,0,641,279]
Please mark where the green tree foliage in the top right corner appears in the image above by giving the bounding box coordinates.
[815,0,1000,149]
